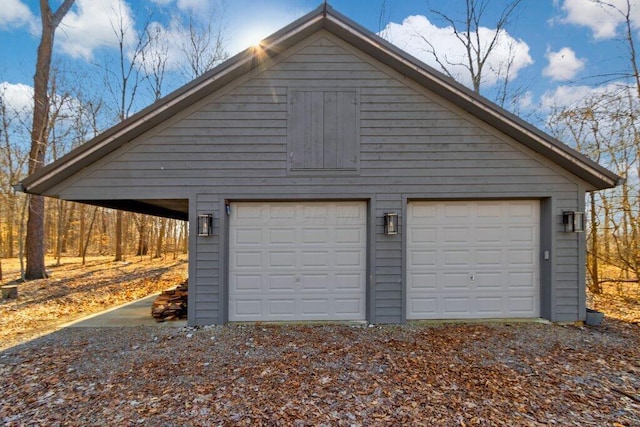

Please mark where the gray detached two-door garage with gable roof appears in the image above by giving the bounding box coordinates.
[18,6,619,325]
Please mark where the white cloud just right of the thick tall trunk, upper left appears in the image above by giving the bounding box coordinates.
[56,0,137,59]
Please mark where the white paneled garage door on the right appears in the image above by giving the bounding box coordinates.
[407,201,540,319]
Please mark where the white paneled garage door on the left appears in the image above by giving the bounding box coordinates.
[229,202,367,321]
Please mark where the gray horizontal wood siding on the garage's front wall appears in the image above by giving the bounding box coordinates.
[52,32,584,324]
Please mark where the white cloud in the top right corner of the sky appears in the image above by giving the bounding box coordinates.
[561,0,640,39]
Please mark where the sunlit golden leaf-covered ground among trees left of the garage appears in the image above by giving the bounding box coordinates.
[0,257,187,350]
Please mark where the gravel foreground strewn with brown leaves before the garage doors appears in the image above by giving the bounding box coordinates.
[0,320,640,426]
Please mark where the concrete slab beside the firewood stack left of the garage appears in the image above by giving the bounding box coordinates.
[63,294,187,328]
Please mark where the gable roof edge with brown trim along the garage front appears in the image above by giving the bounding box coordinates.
[15,4,622,199]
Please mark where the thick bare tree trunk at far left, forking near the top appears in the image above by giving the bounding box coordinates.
[24,0,75,280]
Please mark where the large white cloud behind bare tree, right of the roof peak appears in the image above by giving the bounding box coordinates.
[380,15,533,87]
